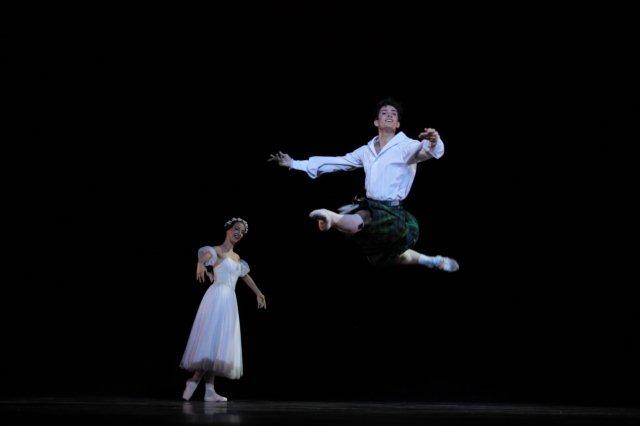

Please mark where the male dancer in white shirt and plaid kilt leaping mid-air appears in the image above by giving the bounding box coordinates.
[269,99,459,272]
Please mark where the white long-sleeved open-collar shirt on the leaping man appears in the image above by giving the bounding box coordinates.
[291,132,444,201]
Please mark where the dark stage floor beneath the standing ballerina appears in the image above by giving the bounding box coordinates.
[0,398,640,425]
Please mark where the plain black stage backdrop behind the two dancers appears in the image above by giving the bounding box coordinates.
[0,3,640,405]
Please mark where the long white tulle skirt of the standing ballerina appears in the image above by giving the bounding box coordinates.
[180,284,242,379]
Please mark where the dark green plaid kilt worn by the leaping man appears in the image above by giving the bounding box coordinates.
[349,198,420,266]
